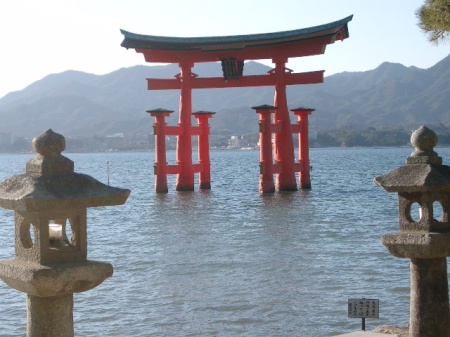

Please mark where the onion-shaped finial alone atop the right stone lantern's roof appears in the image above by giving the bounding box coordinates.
[406,126,442,165]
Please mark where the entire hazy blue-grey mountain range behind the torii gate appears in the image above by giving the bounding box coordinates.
[0,52,450,137]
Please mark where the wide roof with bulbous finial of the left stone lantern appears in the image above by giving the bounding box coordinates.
[0,129,130,212]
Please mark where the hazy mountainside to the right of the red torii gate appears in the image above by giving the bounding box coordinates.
[305,56,450,128]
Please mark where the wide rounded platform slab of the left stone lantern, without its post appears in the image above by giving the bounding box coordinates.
[0,259,113,297]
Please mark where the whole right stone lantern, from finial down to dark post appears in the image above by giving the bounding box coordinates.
[375,126,450,337]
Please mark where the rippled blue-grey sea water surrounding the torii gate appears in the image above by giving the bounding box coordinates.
[0,148,450,337]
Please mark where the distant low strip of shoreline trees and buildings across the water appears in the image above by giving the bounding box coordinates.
[0,125,450,153]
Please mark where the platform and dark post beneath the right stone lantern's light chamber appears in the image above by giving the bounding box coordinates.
[382,232,450,337]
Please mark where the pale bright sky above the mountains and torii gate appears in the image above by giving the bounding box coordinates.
[0,0,450,97]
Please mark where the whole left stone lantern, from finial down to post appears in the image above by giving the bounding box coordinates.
[0,130,130,337]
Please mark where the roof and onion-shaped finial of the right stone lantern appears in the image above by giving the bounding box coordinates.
[375,126,450,193]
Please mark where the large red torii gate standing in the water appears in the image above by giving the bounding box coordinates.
[121,16,353,192]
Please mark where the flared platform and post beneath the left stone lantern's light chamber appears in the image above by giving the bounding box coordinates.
[0,259,113,337]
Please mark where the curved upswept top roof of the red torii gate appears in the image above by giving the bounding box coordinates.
[121,15,353,63]
